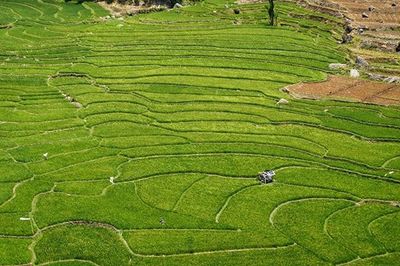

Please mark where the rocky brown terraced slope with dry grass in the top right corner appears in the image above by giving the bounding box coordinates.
[288,0,400,81]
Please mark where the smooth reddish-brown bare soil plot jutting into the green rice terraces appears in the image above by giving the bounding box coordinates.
[285,76,400,105]
